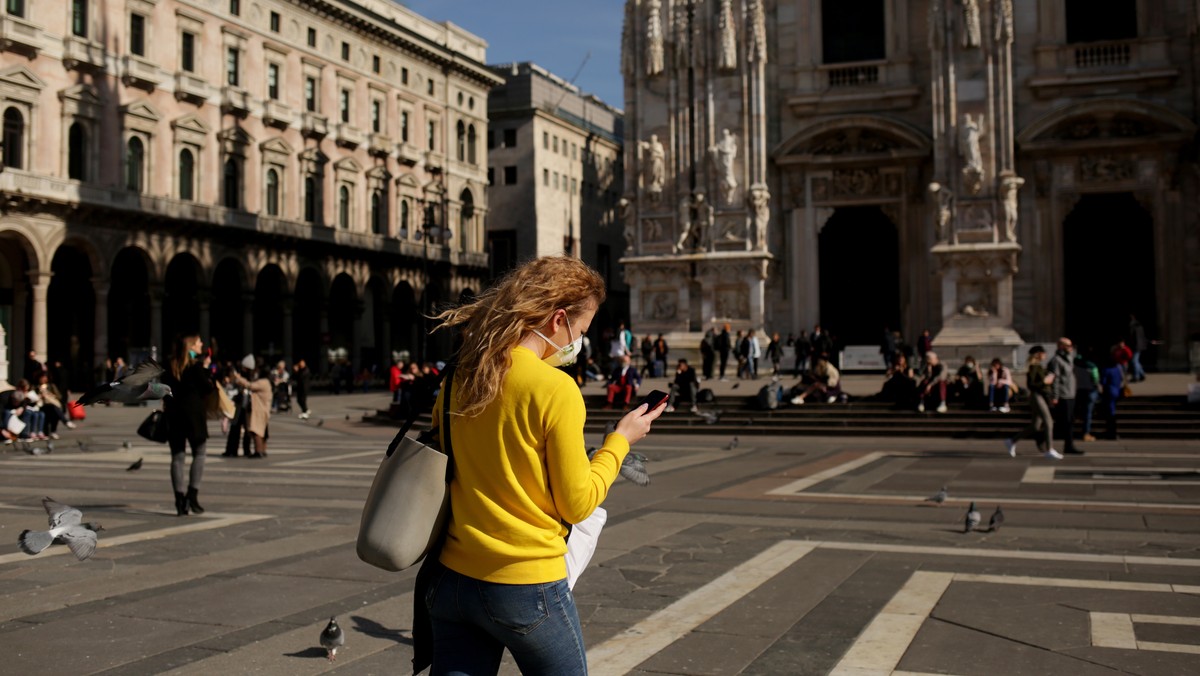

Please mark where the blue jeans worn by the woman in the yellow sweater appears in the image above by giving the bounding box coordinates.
[425,566,588,676]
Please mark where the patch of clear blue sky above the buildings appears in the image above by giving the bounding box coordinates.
[401,0,625,108]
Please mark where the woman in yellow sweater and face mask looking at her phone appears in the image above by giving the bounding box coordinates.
[425,257,662,676]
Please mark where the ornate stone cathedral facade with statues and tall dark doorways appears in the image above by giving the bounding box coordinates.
[622,0,1200,367]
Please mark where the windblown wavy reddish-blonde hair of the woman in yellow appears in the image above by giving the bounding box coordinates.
[434,256,606,417]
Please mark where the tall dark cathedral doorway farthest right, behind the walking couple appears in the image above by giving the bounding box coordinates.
[1062,192,1159,364]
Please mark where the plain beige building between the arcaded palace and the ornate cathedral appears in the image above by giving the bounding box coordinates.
[487,62,629,330]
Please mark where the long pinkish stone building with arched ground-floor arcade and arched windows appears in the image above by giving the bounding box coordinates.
[0,0,500,387]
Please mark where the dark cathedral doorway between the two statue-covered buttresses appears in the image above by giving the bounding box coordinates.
[817,207,900,345]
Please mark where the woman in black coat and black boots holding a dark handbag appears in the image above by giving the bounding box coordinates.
[162,334,215,516]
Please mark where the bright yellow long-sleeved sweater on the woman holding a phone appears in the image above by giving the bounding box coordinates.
[433,347,629,585]
